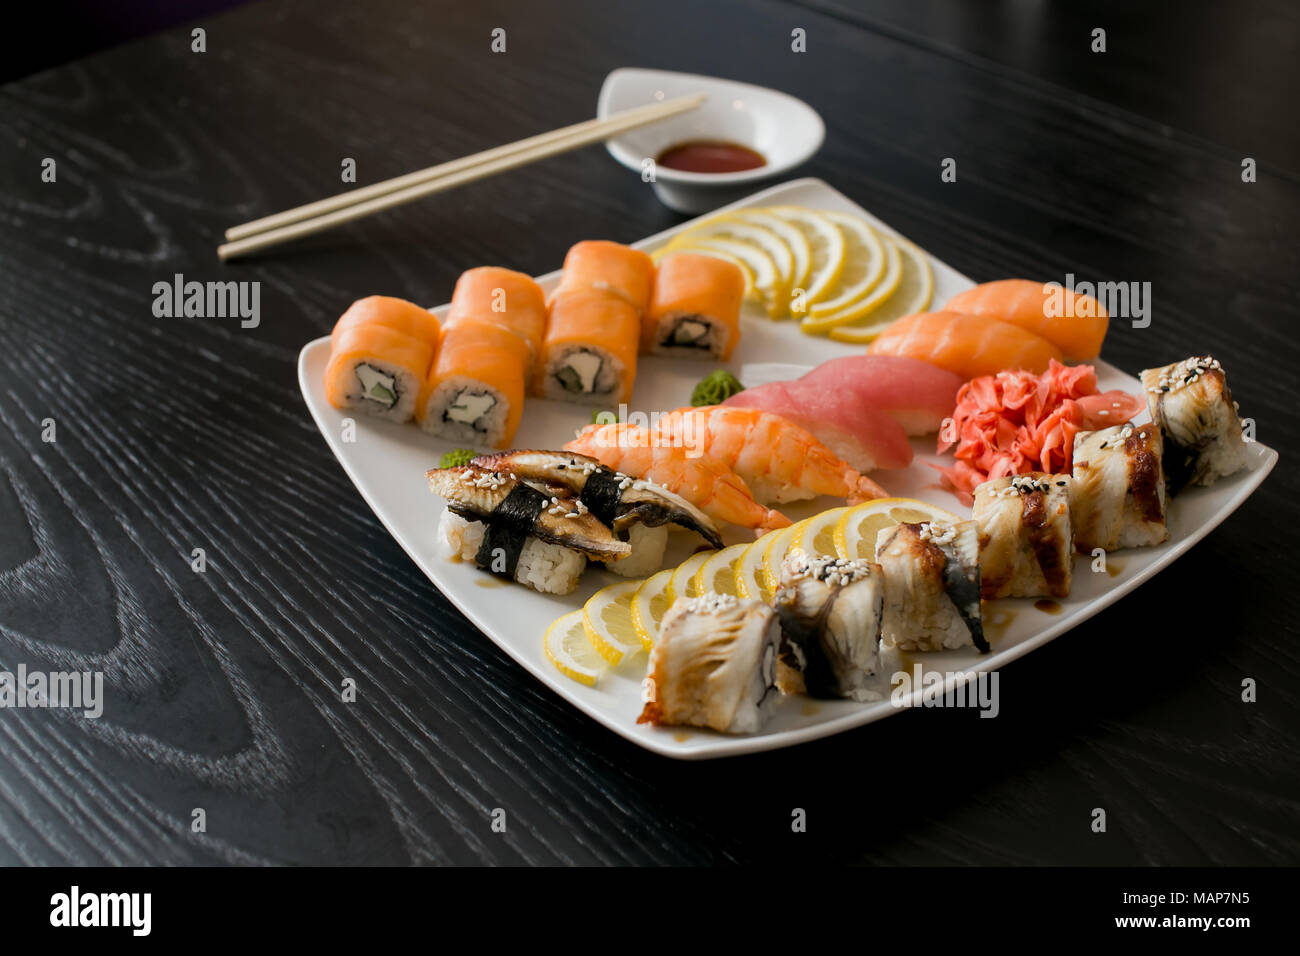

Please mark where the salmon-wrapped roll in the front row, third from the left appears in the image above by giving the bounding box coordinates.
[537,289,641,406]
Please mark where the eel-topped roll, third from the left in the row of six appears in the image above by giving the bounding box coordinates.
[876,522,989,653]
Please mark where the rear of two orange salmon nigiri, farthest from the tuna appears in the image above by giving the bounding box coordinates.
[944,278,1110,371]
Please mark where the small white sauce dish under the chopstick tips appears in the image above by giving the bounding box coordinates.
[595,68,826,213]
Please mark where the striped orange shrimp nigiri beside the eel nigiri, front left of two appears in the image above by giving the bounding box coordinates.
[564,424,790,532]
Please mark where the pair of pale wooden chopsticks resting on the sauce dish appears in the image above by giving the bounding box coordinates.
[217,94,706,260]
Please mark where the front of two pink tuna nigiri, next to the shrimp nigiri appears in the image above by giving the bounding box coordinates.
[723,378,915,472]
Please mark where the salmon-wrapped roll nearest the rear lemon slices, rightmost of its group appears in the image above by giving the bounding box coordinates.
[641,254,745,362]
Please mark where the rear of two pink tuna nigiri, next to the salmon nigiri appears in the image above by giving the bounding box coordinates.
[800,355,962,434]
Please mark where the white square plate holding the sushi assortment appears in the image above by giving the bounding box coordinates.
[298,179,1278,760]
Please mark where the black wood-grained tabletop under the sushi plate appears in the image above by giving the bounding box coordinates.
[0,0,1300,864]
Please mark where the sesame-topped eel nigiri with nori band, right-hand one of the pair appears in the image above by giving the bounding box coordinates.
[471,451,723,578]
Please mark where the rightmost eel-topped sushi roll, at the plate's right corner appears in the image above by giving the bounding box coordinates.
[1141,355,1245,492]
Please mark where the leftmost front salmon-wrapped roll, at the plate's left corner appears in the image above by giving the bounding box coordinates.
[325,324,434,421]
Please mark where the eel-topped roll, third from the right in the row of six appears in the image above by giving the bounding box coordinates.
[971,472,1074,598]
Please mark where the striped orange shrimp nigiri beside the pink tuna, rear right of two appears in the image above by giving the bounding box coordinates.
[655,405,888,505]
